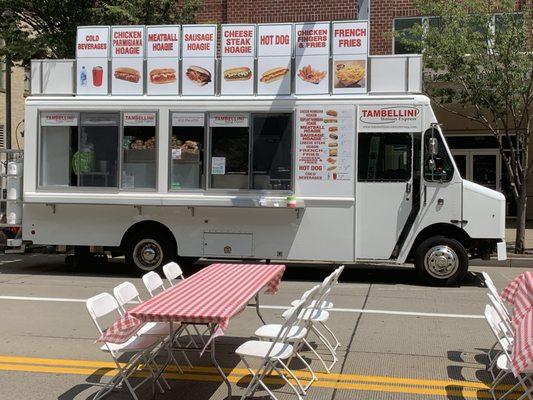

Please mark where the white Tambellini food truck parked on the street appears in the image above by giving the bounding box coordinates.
[18,21,506,285]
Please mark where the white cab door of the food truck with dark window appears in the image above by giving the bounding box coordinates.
[355,132,414,260]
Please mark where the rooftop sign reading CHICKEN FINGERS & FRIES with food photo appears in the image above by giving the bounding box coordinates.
[294,22,330,94]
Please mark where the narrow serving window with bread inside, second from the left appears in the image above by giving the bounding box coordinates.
[122,112,157,190]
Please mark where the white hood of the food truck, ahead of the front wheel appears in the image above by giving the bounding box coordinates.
[463,180,505,240]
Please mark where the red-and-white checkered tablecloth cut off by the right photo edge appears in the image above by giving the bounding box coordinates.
[501,271,533,376]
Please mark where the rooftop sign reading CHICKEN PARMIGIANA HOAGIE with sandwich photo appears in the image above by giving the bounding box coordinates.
[111,26,144,95]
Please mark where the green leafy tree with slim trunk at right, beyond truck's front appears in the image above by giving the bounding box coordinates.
[397,0,533,253]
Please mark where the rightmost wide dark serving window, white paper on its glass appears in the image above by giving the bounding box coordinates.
[209,113,292,190]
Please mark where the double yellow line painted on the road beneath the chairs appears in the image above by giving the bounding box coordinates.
[0,356,512,398]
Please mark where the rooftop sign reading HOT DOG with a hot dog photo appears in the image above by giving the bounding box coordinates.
[257,24,292,95]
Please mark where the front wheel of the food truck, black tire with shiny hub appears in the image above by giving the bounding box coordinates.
[415,236,468,286]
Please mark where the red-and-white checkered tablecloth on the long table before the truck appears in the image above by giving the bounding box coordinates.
[93,264,285,343]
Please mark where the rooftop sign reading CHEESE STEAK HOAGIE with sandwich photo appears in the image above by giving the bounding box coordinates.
[220,25,255,95]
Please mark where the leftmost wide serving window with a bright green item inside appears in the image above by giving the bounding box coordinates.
[39,112,120,187]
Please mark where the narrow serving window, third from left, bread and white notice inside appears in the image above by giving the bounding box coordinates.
[170,113,205,189]
